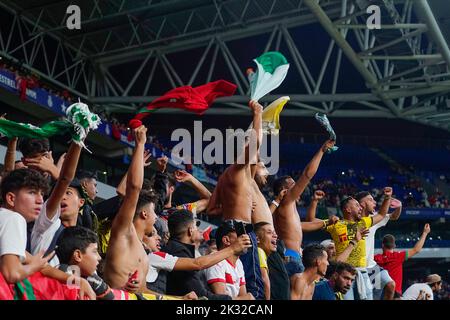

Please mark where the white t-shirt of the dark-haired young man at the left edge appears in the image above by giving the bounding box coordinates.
[0,208,27,261]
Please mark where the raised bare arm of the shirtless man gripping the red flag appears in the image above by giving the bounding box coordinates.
[111,126,147,236]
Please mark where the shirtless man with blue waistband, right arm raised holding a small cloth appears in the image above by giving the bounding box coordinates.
[273,140,335,283]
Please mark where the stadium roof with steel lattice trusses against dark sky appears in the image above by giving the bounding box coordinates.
[0,0,450,130]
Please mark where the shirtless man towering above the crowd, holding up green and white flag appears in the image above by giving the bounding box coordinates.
[207,100,270,300]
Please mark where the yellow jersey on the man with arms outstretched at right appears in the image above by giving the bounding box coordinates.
[327,217,373,268]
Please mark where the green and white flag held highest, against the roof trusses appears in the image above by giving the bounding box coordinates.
[248,51,289,101]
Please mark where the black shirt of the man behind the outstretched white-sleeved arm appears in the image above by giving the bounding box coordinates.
[161,239,231,300]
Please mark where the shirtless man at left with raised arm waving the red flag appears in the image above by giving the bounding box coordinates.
[104,126,196,298]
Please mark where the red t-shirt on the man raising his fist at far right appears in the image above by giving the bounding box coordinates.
[374,251,408,294]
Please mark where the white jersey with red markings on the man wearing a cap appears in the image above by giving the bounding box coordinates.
[206,259,245,298]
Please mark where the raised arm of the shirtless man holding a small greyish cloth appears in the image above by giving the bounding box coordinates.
[283,140,335,204]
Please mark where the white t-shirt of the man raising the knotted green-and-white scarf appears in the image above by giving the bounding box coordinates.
[31,201,61,267]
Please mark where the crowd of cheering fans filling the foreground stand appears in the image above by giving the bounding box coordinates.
[0,101,448,300]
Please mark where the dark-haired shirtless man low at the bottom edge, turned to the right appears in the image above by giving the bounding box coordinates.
[291,244,329,300]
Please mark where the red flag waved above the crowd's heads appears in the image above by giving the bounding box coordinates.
[130,80,237,123]
